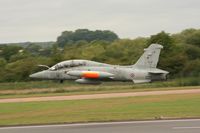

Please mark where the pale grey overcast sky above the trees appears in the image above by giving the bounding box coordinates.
[0,0,200,43]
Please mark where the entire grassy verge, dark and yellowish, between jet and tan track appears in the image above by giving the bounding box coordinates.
[0,77,200,99]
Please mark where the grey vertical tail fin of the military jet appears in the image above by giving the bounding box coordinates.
[135,44,163,68]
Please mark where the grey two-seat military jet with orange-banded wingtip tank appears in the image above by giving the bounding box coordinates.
[30,44,169,84]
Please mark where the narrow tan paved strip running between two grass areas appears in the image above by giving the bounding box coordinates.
[0,89,200,103]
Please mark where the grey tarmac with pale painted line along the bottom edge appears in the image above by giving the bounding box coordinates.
[0,119,200,133]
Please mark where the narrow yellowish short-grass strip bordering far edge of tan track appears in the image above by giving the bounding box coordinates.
[0,85,200,99]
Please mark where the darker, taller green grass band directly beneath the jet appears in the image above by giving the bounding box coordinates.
[0,77,200,90]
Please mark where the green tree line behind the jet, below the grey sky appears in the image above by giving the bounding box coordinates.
[0,29,200,82]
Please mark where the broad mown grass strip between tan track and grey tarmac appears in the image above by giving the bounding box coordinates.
[0,94,200,125]
